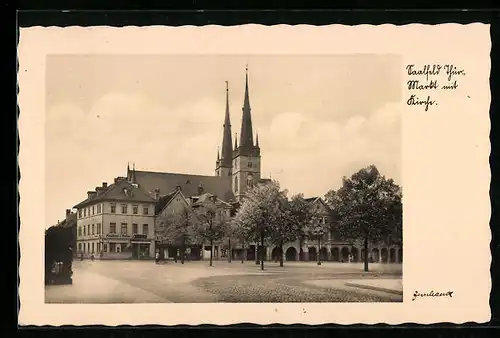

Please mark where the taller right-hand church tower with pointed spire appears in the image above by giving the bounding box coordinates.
[232,67,260,201]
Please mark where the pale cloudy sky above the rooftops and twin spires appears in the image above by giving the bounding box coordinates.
[45,54,403,227]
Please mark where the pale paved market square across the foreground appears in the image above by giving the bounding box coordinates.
[45,261,403,303]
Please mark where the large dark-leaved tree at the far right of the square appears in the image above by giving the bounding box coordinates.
[325,165,402,271]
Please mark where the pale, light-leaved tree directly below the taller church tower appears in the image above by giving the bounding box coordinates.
[233,181,283,270]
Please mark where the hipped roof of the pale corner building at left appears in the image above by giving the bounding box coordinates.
[73,179,155,209]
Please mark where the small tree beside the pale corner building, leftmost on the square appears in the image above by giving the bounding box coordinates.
[155,207,198,264]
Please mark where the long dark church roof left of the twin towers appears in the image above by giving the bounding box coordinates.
[135,170,234,201]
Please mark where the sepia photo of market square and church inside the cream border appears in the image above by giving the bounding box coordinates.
[44,53,405,304]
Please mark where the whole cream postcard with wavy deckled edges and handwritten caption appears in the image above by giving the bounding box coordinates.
[18,23,491,326]
